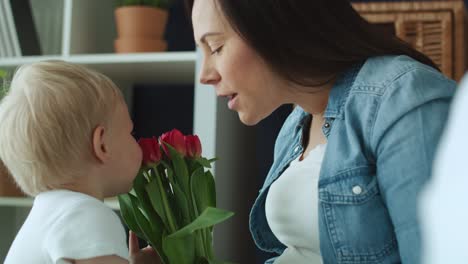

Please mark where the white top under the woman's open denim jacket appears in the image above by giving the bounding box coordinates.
[265,144,326,264]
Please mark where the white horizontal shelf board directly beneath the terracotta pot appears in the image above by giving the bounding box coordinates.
[0,51,196,84]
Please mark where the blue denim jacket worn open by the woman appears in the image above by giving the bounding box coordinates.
[250,56,456,264]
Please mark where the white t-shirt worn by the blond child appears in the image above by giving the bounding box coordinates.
[5,190,128,264]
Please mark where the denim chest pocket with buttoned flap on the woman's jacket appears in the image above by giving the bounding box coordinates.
[319,167,399,263]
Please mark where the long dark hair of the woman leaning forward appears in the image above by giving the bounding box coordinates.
[186,0,438,86]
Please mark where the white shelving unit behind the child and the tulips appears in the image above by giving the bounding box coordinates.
[0,0,258,263]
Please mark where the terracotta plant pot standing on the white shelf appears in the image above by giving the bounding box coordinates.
[114,0,171,53]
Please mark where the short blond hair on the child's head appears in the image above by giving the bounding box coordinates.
[0,61,123,196]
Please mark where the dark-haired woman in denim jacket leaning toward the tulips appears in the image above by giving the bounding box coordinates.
[187,0,456,264]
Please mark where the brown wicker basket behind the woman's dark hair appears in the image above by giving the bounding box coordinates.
[353,0,468,81]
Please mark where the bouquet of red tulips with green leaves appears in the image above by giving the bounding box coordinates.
[119,129,233,264]
